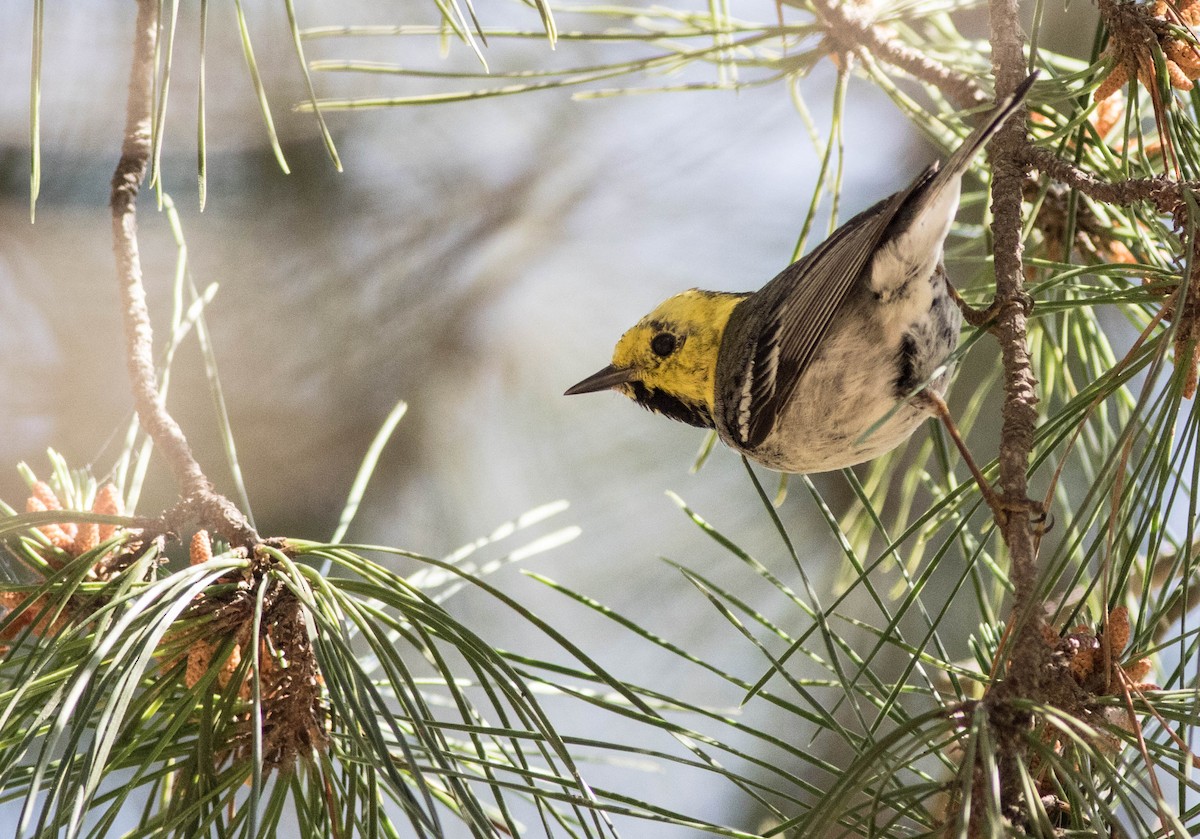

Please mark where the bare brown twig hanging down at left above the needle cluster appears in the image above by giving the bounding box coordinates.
[110,0,258,545]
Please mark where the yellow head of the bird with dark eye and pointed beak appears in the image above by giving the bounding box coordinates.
[566,288,746,429]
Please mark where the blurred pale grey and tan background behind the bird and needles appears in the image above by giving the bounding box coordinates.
[0,0,1099,835]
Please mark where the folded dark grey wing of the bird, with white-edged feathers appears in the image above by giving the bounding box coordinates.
[726,164,937,449]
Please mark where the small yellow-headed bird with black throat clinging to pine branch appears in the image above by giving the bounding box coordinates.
[565,73,1037,477]
